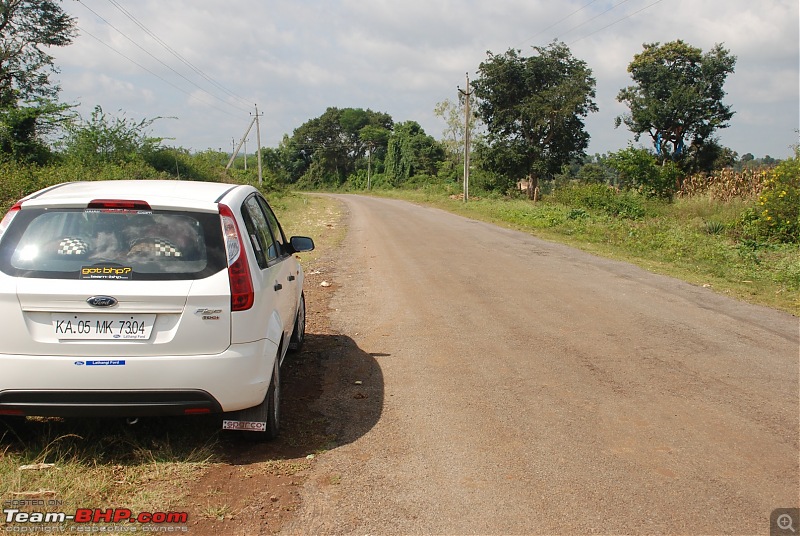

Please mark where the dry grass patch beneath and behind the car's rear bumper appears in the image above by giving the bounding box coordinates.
[0,417,218,528]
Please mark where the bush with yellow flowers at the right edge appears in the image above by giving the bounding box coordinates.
[757,149,800,242]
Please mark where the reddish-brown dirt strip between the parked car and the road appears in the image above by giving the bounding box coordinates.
[174,249,349,536]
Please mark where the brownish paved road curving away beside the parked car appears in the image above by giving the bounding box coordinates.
[284,196,800,534]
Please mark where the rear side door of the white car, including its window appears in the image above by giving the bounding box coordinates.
[242,194,296,350]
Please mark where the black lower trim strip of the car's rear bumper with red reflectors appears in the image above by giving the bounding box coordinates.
[0,390,222,417]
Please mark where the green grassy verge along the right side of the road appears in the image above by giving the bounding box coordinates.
[366,187,800,316]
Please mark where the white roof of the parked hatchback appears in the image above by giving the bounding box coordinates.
[22,180,255,211]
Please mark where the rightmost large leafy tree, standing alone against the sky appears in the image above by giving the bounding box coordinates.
[615,40,736,174]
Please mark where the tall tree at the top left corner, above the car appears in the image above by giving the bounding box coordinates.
[0,0,76,161]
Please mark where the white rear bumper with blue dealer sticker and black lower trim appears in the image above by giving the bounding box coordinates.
[0,339,278,417]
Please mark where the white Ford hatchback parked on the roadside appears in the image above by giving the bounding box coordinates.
[0,180,314,438]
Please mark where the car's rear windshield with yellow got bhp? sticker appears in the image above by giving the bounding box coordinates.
[0,208,226,280]
